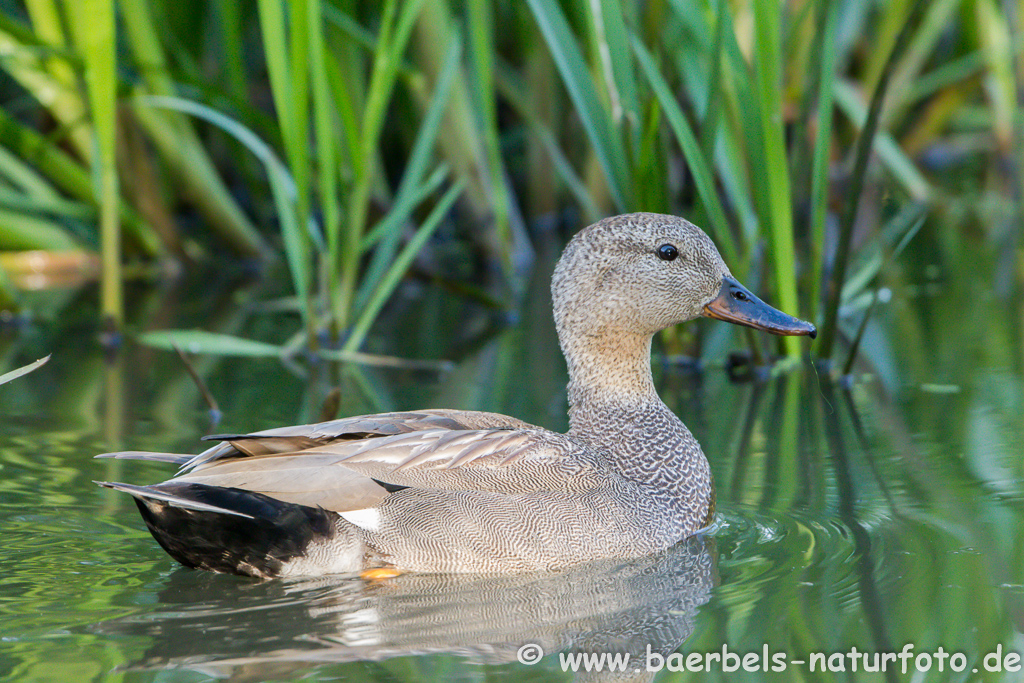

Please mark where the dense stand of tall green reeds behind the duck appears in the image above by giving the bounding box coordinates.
[0,0,1024,368]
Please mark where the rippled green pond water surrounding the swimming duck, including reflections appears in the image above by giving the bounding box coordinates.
[0,233,1024,682]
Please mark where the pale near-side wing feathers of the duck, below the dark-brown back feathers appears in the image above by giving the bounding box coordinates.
[171,427,617,512]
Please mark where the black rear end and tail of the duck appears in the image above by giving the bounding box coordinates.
[96,481,338,579]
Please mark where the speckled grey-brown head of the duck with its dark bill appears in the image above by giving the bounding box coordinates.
[551,213,816,345]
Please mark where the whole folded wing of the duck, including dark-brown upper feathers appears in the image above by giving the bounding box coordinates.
[97,411,615,512]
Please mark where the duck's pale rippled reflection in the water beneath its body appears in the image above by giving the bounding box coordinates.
[97,536,717,680]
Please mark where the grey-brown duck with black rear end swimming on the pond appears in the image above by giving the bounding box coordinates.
[96,213,816,580]
